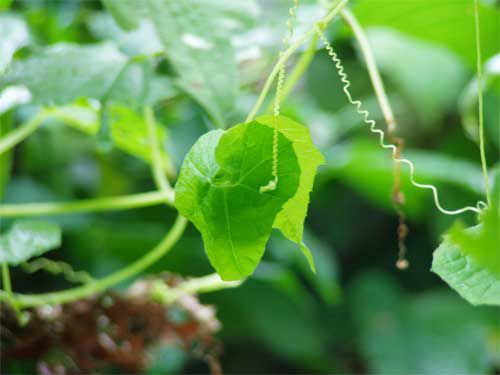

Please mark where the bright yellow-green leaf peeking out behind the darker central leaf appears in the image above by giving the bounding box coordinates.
[256,116,325,272]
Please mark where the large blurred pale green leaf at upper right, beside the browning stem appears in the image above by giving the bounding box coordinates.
[367,28,467,128]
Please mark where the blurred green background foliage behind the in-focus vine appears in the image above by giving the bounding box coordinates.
[0,0,500,374]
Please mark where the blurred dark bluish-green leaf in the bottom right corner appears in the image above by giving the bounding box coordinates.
[351,273,490,374]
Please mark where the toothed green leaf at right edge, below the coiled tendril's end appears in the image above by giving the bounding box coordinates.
[432,207,500,305]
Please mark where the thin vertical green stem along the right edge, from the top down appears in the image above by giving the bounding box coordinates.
[474,0,491,206]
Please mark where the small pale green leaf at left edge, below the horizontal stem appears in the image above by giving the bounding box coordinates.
[0,220,61,265]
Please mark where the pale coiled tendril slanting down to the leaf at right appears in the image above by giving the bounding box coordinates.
[316,25,487,215]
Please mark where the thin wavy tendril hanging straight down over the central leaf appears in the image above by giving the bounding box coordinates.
[260,0,299,193]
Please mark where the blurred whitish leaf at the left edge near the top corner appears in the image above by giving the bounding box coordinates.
[0,13,29,73]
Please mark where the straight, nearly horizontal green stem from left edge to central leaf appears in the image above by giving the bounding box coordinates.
[0,191,174,217]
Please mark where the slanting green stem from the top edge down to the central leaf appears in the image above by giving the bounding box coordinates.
[245,0,349,122]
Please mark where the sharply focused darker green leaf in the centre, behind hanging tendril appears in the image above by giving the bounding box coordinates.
[175,121,300,280]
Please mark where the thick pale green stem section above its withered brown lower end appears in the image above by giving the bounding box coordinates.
[340,8,396,133]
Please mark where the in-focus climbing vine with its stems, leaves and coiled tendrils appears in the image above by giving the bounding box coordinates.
[0,0,500,342]
